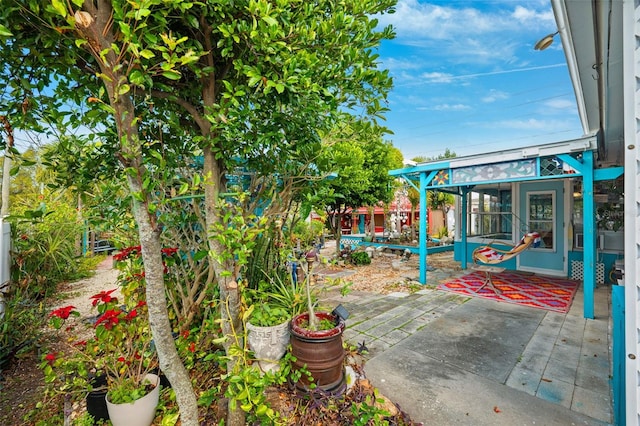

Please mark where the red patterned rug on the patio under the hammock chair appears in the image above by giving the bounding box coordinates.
[438,271,580,313]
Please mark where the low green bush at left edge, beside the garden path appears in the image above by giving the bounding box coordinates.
[0,289,46,371]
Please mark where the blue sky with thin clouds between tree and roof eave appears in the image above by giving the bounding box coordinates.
[379,0,582,159]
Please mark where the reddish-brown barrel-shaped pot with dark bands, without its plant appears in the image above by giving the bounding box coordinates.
[290,312,345,393]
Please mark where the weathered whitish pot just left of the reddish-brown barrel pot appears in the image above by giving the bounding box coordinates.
[247,321,289,371]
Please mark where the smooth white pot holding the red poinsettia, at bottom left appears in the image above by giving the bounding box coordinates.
[106,374,160,426]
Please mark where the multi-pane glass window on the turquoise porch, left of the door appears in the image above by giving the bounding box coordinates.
[467,185,513,241]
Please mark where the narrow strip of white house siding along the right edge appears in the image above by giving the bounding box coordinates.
[622,1,640,425]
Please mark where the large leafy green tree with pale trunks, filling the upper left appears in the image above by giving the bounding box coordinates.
[0,0,395,425]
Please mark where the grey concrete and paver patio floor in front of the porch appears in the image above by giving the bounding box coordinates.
[325,269,613,425]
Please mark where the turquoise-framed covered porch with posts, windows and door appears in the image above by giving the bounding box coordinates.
[390,135,624,318]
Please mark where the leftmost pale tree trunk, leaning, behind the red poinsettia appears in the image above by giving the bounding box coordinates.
[76,0,199,426]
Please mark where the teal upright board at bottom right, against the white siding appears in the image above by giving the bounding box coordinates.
[611,285,627,426]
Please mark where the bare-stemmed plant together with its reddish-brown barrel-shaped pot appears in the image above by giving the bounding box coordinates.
[290,249,346,394]
